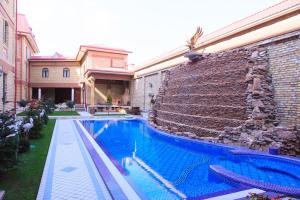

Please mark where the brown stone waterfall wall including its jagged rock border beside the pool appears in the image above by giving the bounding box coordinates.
[149,47,300,155]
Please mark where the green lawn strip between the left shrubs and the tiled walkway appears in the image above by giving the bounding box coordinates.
[0,119,55,200]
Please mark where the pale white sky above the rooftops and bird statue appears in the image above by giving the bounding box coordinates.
[18,0,280,65]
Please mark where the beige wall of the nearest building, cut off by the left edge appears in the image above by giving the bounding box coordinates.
[0,0,16,110]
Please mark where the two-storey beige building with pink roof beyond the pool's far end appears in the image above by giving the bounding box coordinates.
[29,45,133,110]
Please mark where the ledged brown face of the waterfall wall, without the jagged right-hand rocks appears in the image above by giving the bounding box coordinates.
[153,49,251,137]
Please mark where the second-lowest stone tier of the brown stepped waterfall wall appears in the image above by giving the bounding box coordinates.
[157,110,244,131]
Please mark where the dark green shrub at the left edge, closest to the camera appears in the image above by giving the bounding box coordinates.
[0,113,19,172]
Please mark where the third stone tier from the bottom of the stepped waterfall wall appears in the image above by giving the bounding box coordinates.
[159,103,247,120]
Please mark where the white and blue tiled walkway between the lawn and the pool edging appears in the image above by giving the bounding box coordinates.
[37,119,111,200]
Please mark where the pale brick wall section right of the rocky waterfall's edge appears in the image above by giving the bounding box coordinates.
[267,32,300,126]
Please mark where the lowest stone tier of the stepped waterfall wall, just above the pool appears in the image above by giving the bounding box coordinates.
[156,117,222,137]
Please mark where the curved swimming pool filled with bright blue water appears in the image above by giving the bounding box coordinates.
[81,119,300,199]
